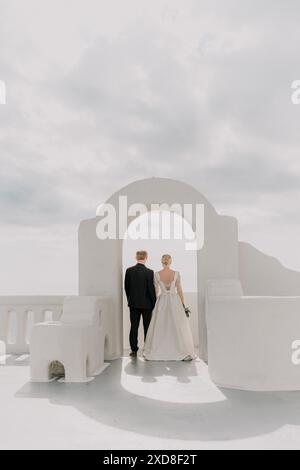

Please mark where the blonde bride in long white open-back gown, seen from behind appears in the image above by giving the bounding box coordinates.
[143,255,196,361]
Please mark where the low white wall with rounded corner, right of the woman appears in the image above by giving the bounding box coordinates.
[207,297,300,391]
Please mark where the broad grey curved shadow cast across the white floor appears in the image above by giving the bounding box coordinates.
[16,359,300,441]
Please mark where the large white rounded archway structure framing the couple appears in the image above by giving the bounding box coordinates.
[79,178,239,360]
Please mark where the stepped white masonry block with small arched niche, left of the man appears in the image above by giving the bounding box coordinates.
[30,296,112,382]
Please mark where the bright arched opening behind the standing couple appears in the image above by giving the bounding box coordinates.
[122,211,199,355]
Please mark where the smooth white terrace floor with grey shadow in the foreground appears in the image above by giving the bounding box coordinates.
[0,357,300,449]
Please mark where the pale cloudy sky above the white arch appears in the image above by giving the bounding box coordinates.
[0,0,300,294]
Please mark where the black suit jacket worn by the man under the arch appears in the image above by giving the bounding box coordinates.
[125,263,156,310]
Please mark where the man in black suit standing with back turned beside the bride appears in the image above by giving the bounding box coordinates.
[125,251,156,358]
